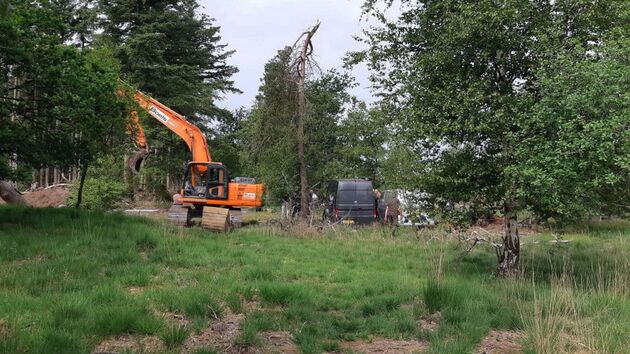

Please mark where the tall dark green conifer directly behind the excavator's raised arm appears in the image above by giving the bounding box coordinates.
[99,0,238,188]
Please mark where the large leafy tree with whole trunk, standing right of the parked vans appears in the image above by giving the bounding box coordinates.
[353,0,628,274]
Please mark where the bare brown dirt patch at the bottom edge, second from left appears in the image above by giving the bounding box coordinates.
[182,314,248,353]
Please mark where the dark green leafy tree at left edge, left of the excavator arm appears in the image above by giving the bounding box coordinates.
[0,1,125,206]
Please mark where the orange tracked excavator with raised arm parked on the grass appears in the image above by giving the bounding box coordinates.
[127,91,265,232]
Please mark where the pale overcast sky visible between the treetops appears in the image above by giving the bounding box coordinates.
[200,0,373,109]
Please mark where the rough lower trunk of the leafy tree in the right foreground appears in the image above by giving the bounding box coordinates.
[498,202,521,276]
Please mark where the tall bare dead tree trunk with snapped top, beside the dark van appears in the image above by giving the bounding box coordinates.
[296,22,319,218]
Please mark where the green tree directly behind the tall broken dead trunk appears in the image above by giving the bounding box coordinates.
[242,48,352,203]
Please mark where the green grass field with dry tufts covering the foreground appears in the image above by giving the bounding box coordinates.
[0,206,630,353]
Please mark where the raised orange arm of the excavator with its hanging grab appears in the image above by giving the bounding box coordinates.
[127,91,212,174]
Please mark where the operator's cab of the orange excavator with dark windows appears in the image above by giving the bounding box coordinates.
[184,162,229,200]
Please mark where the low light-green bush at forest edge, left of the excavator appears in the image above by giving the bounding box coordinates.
[66,176,129,210]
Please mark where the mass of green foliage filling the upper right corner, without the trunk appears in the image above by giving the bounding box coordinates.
[358,0,630,222]
